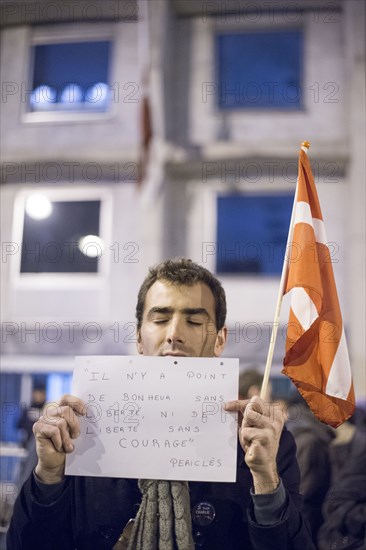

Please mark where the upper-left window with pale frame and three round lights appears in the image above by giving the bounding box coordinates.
[22,22,118,123]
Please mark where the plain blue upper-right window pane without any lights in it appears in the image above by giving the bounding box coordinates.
[216,30,303,110]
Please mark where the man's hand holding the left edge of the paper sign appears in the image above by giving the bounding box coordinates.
[33,395,86,484]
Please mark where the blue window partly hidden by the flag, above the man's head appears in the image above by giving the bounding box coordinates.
[216,194,293,275]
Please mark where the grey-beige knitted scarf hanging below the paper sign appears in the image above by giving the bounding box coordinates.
[113,479,194,550]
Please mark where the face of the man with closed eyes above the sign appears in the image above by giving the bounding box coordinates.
[137,280,226,357]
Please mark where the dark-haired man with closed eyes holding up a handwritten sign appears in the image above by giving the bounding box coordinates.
[8,259,314,550]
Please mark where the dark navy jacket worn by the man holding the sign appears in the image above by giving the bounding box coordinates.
[7,430,314,550]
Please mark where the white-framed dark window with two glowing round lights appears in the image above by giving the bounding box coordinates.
[11,187,112,288]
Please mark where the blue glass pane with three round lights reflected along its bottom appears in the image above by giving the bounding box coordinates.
[29,40,111,112]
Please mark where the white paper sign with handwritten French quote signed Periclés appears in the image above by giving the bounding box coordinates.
[65,356,239,482]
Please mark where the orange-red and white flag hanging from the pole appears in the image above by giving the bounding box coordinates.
[282,150,355,428]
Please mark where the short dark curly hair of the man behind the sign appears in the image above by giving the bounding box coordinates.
[136,258,226,330]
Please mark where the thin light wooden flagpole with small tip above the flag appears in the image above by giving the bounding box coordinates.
[260,141,310,399]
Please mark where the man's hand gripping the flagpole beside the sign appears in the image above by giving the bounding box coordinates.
[225,396,284,493]
